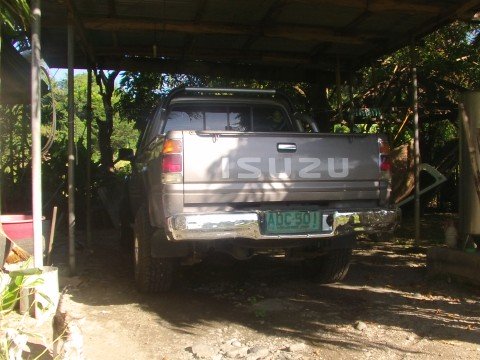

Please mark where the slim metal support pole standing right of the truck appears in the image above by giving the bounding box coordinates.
[410,43,420,244]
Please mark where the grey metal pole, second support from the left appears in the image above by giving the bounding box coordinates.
[67,22,76,276]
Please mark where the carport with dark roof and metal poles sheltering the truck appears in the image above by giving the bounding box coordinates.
[5,0,480,269]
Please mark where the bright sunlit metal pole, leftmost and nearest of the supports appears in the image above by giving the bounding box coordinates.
[31,0,43,268]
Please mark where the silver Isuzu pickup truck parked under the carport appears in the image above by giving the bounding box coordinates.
[122,87,399,292]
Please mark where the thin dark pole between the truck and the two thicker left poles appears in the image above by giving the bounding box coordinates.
[86,69,93,249]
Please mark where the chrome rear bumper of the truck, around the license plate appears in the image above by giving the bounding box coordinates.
[167,208,401,240]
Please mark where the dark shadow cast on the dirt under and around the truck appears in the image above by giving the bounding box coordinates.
[52,218,480,353]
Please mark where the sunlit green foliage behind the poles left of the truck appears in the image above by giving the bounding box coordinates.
[0,70,138,217]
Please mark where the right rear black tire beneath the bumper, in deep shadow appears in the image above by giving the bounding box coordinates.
[303,249,352,284]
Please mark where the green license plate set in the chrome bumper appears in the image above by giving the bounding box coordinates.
[265,211,322,234]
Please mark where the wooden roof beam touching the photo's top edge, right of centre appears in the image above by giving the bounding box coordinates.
[286,0,444,14]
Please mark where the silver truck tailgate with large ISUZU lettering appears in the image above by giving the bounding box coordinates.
[183,131,380,205]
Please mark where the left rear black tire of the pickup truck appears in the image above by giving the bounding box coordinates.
[133,207,176,293]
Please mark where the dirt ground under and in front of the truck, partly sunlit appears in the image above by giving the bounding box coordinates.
[3,217,480,360]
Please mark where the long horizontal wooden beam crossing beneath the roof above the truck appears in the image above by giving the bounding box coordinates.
[45,17,370,45]
